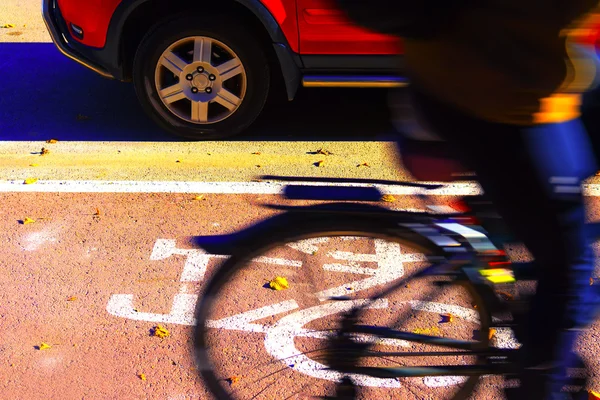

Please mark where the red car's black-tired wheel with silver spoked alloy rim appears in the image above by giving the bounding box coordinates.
[133,15,271,140]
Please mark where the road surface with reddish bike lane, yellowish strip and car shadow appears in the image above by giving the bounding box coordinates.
[0,0,600,400]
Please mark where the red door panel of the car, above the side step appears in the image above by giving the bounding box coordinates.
[296,0,400,55]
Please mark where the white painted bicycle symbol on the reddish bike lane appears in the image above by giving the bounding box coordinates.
[106,238,519,388]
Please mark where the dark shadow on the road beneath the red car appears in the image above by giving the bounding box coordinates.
[0,43,393,141]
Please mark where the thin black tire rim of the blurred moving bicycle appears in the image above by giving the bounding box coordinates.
[193,212,489,400]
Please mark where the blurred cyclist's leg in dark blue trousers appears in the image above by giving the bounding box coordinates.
[400,86,599,398]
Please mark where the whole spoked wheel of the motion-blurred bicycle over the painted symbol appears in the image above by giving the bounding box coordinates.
[194,215,489,400]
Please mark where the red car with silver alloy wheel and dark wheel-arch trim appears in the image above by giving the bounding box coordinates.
[42,0,404,139]
